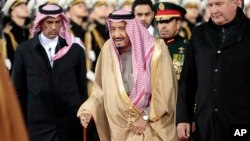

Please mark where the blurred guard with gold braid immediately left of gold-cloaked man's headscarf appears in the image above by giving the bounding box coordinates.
[84,1,109,81]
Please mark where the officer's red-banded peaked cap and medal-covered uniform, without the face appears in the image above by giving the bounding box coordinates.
[154,2,187,79]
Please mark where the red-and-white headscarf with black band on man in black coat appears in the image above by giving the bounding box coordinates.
[32,4,75,61]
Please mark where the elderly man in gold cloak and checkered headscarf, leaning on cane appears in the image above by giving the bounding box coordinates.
[78,10,178,141]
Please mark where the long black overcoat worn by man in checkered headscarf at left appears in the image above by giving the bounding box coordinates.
[12,35,87,141]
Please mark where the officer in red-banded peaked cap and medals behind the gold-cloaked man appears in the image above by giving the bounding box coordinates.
[154,2,187,79]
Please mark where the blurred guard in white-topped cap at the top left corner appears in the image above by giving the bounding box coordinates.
[2,0,30,73]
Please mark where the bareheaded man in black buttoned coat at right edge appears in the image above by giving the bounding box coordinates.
[177,0,250,141]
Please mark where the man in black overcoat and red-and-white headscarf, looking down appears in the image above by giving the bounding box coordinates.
[12,4,87,141]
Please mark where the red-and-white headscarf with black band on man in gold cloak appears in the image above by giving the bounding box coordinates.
[107,10,154,108]
